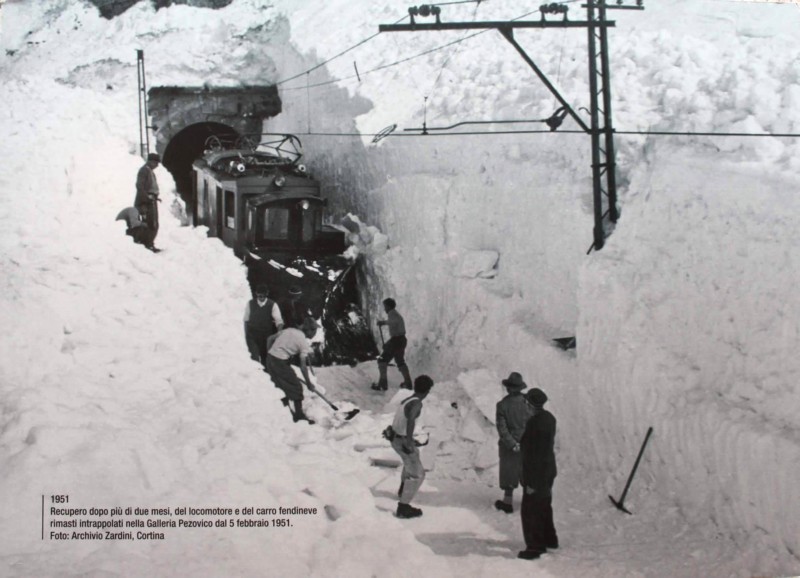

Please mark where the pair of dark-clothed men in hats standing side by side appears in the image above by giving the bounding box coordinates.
[494,371,558,560]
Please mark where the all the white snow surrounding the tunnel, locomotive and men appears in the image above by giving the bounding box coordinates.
[0,0,800,577]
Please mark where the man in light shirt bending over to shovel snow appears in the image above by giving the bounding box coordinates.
[267,317,317,424]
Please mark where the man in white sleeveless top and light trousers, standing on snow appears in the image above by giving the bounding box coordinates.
[392,375,433,518]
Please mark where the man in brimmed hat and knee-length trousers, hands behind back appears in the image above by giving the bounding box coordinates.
[494,371,533,514]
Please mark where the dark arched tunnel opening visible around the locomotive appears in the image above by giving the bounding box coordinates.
[161,122,239,206]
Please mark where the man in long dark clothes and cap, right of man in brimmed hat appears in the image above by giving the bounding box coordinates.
[518,388,558,560]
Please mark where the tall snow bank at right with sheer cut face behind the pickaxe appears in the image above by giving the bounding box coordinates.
[578,146,800,571]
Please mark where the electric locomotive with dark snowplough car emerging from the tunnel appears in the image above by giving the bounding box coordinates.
[192,135,377,364]
